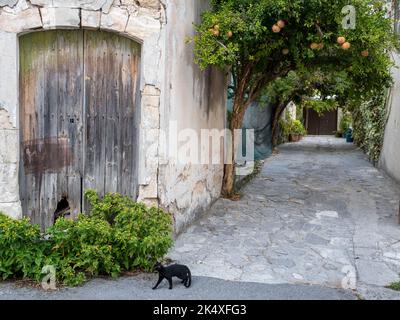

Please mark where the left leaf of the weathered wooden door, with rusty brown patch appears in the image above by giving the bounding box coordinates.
[20,30,83,229]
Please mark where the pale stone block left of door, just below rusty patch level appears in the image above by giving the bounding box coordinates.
[0,163,19,202]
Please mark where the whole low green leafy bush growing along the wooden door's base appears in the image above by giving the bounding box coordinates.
[0,191,172,286]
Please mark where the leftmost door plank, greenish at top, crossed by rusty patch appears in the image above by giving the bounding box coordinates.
[20,33,55,226]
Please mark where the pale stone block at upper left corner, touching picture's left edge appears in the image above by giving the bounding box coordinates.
[0,8,42,33]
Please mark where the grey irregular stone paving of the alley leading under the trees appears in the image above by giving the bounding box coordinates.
[169,136,400,299]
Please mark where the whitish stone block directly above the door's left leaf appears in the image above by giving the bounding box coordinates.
[40,8,81,29]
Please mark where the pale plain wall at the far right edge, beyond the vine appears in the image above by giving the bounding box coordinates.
[379,54,400,182]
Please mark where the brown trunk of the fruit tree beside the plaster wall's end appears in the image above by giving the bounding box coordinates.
[222,98,247,198]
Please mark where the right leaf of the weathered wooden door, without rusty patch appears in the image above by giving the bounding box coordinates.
[84,31,140,199]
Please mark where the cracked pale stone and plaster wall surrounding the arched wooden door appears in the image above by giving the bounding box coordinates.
[0,0,226,232]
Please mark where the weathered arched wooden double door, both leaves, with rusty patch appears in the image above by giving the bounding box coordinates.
[20,30,140,228]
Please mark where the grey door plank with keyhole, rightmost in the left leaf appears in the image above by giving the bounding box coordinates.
[57,31,83,218]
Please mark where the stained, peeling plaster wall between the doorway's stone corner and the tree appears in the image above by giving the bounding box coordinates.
[159,0,227,233]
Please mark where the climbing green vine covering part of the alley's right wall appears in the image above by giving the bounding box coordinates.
[351,89,388,165]
